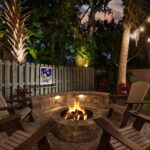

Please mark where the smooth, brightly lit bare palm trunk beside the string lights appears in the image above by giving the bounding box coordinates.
[117,25,131,87]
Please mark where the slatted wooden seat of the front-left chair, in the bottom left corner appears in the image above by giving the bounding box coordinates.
[0,130,31,150]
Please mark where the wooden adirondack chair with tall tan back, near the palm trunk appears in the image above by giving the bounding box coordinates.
[107,81,150,128]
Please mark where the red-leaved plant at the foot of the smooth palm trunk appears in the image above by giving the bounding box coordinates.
[119,83,131,95]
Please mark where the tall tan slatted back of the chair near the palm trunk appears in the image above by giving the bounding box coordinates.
[128,81,149,111]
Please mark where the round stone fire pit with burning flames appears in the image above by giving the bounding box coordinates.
[51,101,101,143]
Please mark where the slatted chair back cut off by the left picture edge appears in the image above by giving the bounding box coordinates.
[0,92,9,118]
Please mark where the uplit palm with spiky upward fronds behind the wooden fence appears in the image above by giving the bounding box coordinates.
[3,0,30,63]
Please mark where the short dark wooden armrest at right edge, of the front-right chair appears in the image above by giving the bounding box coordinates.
[129,110,150,123]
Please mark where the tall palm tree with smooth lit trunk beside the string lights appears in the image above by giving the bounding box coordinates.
[117,0,150,87]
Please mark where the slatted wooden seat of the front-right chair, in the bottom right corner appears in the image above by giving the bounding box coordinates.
[110,126,150,150]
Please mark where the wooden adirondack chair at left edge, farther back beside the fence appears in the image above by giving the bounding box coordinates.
[0,93,33,121]
